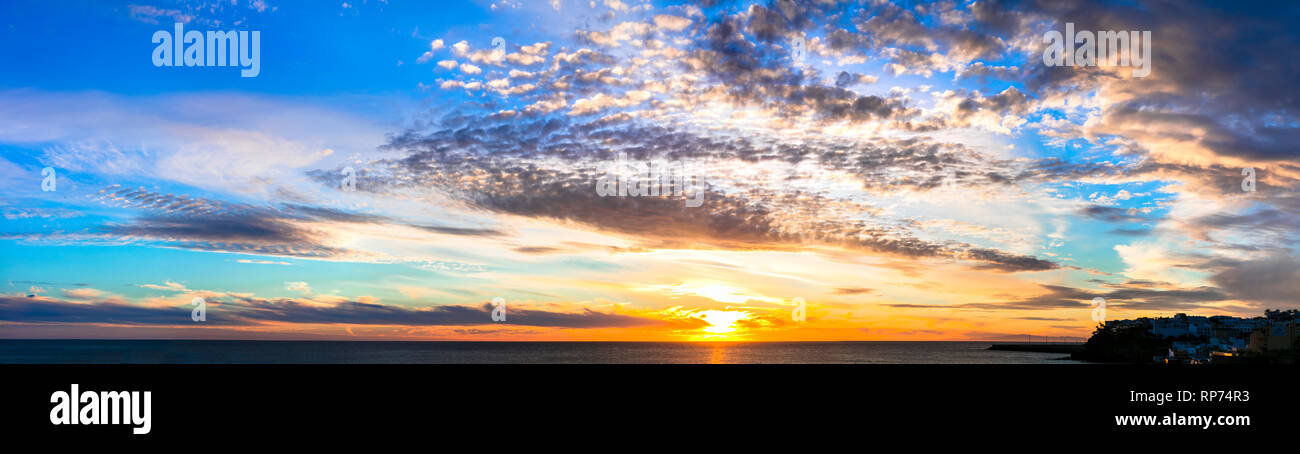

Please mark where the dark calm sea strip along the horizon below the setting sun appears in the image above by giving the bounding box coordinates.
[0,340,1079,364]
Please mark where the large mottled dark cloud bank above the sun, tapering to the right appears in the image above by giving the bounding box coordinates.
[361,87,1057,272]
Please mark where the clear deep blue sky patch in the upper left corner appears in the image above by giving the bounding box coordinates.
[0,1,489,96]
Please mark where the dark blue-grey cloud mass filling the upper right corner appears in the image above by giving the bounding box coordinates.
[1019,1,1300,161]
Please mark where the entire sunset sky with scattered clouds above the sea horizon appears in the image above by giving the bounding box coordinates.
[0,0,1300,341]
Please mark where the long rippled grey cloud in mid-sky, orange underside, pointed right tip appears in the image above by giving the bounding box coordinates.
[359,111,1057,272]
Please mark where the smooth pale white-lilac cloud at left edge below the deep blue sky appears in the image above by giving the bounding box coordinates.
[0,90,384,194]
